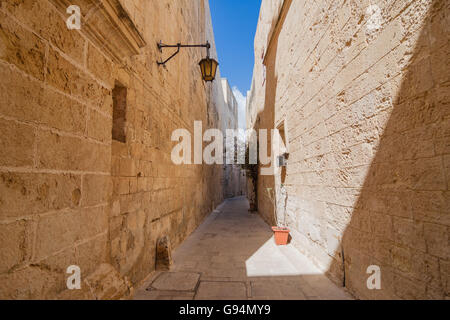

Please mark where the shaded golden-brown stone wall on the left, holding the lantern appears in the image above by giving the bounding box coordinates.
[0,0,223,299]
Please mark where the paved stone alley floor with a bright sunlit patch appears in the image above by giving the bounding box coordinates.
[134,197,351,300]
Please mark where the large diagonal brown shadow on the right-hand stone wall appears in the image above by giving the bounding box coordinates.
[328,1,450,299]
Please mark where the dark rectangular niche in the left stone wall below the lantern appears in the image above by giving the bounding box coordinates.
[112,82,127,142]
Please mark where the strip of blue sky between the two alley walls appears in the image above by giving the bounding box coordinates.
[209,0,261,126]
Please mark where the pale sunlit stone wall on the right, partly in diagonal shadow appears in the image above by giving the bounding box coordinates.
[249,0,450,299]
